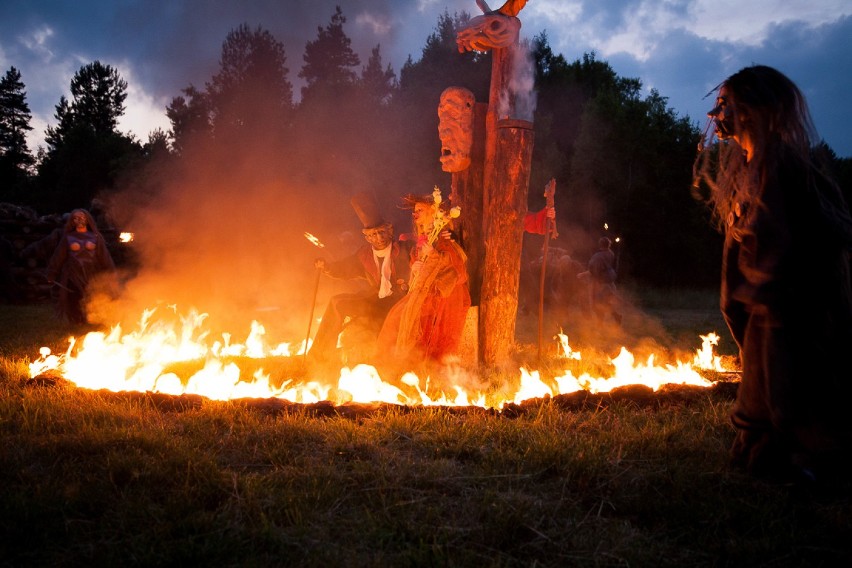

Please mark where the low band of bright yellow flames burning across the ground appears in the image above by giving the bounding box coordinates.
[30,306,724,408]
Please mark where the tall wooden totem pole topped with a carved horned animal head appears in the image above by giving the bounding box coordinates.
[450,0,534,366]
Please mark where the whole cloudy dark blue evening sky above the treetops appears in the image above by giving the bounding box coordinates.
[0,0,852,157]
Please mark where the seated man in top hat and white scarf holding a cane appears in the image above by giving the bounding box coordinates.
[308,192,409,364]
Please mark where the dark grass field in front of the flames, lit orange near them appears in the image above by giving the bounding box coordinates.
[0,296,852,567]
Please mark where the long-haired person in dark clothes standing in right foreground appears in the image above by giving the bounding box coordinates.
[696,65,852,479]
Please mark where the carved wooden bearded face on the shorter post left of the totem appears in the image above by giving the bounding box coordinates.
[438,87,476,172]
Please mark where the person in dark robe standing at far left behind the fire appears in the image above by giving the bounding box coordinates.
[47,209,115,324]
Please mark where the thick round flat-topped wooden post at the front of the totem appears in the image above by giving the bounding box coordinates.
[479,118,534,365]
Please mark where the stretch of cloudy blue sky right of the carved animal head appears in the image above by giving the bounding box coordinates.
[521,0,852,156]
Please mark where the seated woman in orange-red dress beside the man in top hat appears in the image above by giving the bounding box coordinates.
[379,188,470,361]
